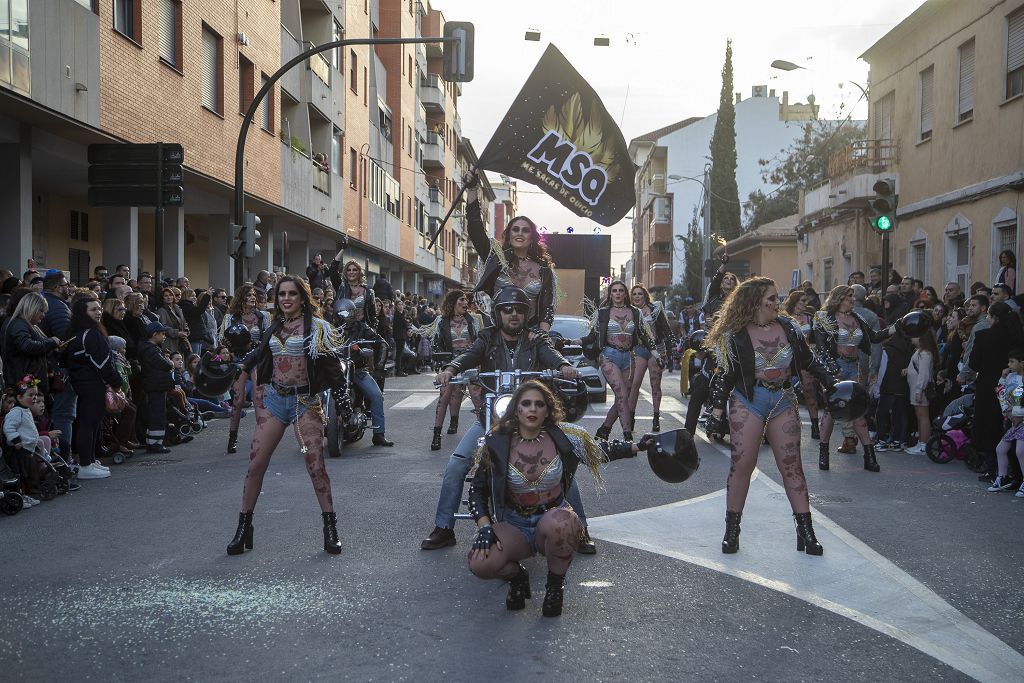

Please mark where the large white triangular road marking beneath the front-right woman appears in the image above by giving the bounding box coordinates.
[589,395,1024,681]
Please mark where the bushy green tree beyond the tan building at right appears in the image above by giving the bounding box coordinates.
[743,113,865,230]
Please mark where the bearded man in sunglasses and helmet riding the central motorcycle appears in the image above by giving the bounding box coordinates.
[420,287,583,550]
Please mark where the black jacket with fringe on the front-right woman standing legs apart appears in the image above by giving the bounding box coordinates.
[709,317,836,409]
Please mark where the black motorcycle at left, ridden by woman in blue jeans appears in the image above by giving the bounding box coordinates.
[325,339,381,458]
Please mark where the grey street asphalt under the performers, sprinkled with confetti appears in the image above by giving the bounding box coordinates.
[0,375,1024,681]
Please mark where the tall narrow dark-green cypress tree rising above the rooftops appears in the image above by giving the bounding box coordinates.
[711,40,740,241]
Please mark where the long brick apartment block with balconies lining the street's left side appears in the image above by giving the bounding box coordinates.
[0,0,477,290]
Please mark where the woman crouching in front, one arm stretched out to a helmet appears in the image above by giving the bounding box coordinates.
[469,381,646,616]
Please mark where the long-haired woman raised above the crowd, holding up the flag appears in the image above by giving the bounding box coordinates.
[463,172,557,332]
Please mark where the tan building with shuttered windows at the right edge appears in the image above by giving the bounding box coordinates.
[862,0,1024,289]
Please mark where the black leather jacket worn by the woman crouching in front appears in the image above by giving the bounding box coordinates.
[469,424,633,522]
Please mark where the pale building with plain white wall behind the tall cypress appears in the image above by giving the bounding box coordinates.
[630,86,818,289]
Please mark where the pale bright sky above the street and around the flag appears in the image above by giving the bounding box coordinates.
[431,0,923,271]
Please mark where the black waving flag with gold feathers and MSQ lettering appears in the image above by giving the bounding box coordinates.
[477,45,636,225]
